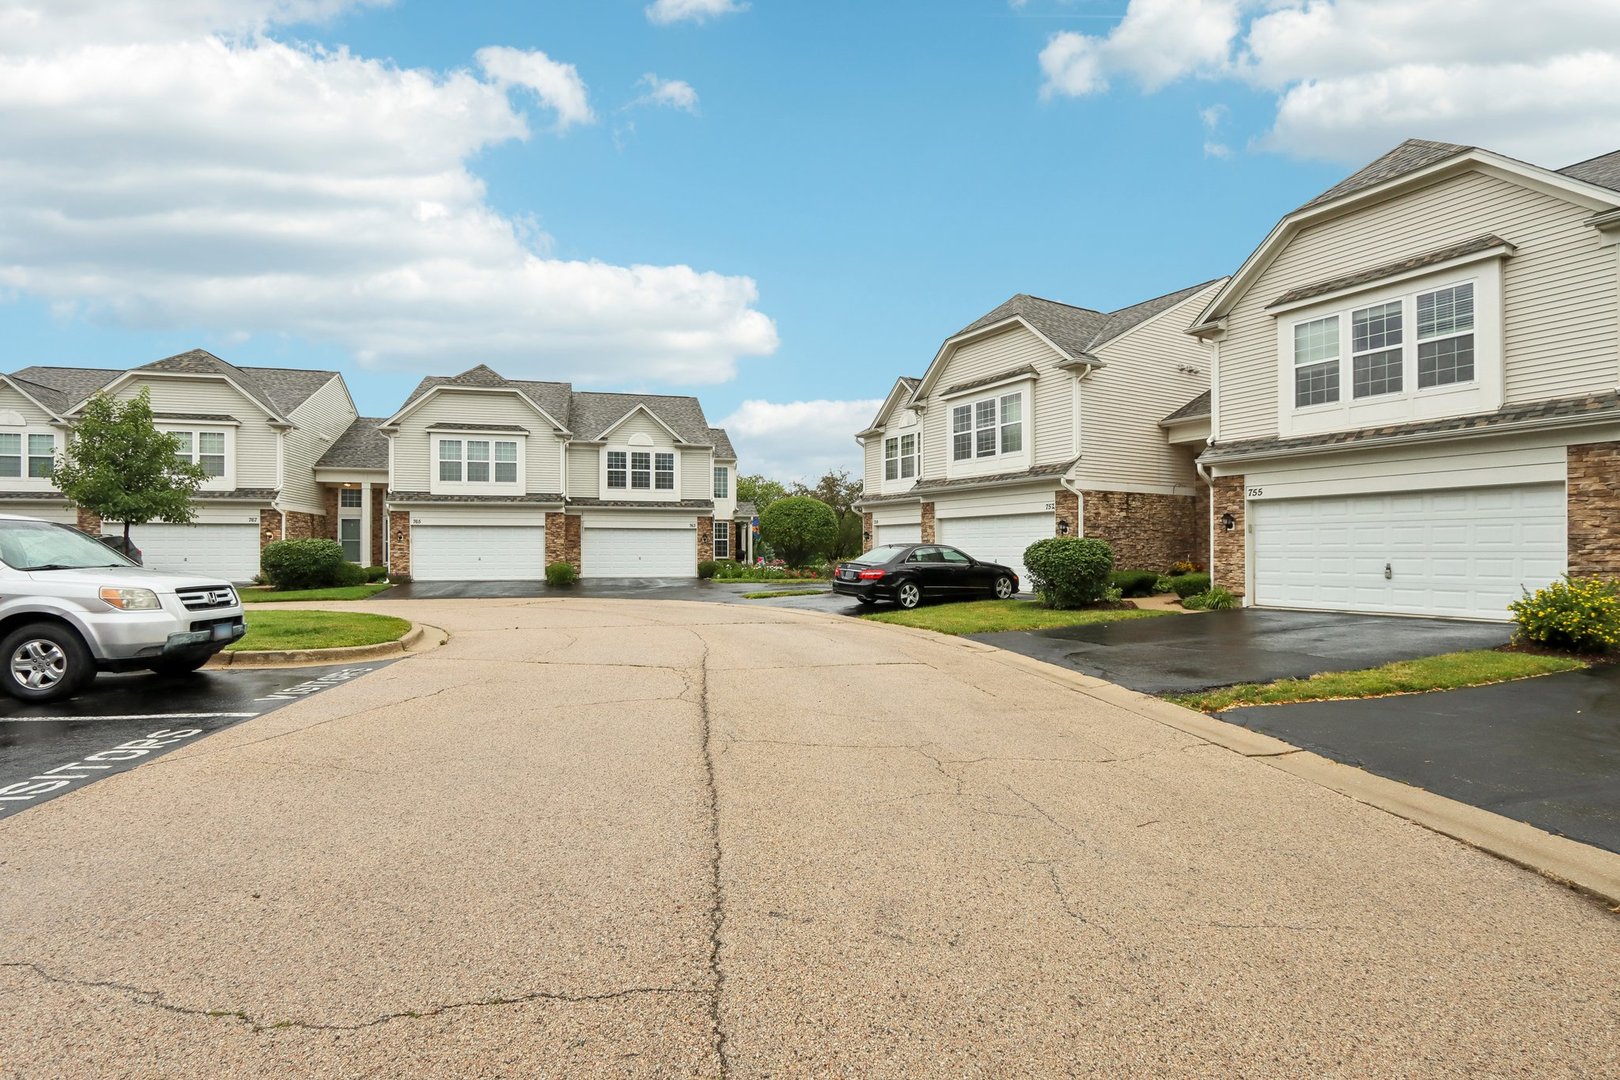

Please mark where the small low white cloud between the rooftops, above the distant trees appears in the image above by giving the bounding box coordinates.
[719,398,883,483]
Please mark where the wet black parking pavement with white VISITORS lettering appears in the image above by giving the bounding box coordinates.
[0,659,394,818]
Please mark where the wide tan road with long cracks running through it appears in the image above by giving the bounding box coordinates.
[0,599,1620,1077]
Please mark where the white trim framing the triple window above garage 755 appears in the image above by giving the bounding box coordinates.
[1277,257,1503,437]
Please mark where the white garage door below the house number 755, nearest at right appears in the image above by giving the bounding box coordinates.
[1249,484,1567,620]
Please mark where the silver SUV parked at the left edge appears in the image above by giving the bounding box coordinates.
[0,515,246,701]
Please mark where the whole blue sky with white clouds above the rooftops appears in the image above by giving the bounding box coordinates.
[0,0,1620,479]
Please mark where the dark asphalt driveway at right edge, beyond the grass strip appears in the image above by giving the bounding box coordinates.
[1220,664,1620,852]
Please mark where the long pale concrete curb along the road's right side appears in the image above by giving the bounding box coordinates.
[829,612,1620,907]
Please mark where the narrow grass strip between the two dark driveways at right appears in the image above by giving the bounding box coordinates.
[1168,649,1586,712]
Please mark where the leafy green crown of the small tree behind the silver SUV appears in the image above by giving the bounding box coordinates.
[50,387,207,542]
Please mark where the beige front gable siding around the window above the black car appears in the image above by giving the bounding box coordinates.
[920,325,1069,479]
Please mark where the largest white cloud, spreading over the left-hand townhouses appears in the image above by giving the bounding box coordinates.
[0,0,776,384]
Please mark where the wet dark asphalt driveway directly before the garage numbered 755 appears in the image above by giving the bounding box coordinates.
[974,607,1511,695]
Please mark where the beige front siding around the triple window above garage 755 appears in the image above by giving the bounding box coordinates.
[1218,173,1617,442]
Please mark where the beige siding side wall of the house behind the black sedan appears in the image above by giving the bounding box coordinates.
[1077,285,1218,484]
